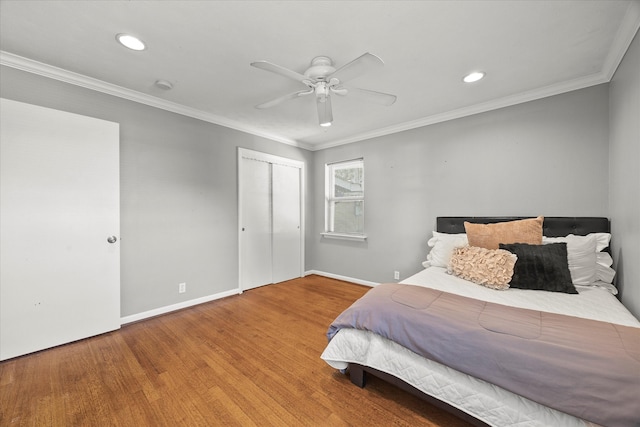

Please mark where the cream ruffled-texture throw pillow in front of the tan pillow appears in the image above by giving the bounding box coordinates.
[447,246,518,290]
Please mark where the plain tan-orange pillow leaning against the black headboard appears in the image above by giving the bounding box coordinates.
[464,216,544,249]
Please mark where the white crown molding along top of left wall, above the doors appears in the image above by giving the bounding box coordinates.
[0,51,309,150]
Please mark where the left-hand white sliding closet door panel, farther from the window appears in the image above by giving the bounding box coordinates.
[240,158,273,290]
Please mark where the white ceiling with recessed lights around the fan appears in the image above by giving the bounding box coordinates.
[0,0,640,150]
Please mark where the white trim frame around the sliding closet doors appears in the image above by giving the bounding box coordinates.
[237,147,305,292]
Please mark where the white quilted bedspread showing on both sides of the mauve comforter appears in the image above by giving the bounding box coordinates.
[321,267,640,427]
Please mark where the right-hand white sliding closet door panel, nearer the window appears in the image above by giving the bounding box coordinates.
[272,164,302,283]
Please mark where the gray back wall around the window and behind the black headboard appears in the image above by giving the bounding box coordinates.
[311,85,609,282]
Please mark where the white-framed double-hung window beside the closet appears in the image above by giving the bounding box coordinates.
[324,159,366,240]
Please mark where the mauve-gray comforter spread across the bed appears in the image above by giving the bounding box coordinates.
[327,283,640,427]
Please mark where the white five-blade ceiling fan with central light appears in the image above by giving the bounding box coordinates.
[251,52,397,126]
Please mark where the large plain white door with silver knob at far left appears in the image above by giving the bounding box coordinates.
[0,99,120,360]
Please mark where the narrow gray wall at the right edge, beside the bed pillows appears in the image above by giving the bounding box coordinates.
[609,31,640,318]
